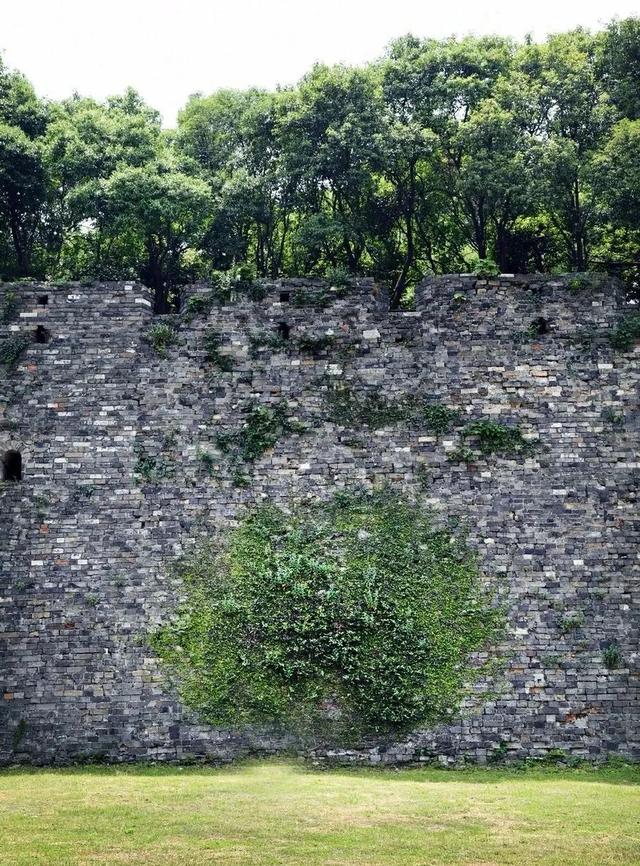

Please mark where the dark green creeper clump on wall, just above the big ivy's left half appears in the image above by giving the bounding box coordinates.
[216,403,304,463]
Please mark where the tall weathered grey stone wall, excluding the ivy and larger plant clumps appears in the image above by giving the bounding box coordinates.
[0,276,640,762]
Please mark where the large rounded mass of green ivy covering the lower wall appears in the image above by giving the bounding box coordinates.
[152,492,503,734]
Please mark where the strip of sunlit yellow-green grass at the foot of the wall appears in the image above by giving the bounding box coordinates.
[0,762,640,866]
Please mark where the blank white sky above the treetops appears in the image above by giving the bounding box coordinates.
[0,0,640,126]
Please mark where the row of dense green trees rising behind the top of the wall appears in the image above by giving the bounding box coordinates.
[0,18,640,310]
